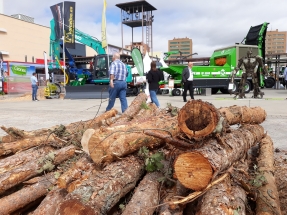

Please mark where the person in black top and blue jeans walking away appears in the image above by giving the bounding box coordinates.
[146,61,164,107]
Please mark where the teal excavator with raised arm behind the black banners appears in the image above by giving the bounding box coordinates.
[49,20,138,99]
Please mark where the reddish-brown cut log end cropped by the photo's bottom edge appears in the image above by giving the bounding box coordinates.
[57,199,97,215]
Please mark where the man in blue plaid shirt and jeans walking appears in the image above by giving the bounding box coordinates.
[106,53,128,113]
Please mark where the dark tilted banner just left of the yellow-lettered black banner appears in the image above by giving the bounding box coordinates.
[50,3,64,40]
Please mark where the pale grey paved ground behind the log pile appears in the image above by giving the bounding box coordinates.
[0,89,287,149]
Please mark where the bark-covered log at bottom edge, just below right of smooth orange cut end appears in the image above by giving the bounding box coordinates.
[196,177,247,215]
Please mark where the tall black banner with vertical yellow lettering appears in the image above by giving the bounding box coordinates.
[64,1,76,49]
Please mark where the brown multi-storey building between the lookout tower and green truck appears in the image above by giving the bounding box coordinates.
[168,37,192,60]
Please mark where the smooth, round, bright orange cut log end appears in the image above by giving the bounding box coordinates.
[174,152,213,191]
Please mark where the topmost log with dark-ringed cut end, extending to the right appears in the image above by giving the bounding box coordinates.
[178,100,266,138]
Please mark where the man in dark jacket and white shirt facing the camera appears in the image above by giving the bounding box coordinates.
[181,62,194,102]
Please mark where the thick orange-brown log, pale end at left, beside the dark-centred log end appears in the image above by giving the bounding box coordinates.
[86,115,177,164]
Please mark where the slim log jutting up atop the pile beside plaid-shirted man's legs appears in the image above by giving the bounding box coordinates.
[114,93,147,125]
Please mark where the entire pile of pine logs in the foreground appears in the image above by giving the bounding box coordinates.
[0,94,281,215]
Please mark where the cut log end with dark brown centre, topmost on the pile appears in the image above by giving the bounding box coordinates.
[178,100,220,138]
